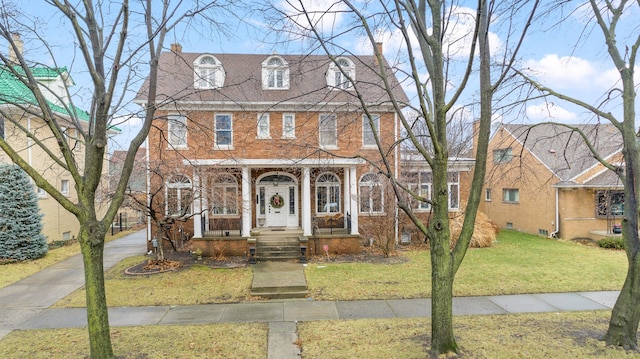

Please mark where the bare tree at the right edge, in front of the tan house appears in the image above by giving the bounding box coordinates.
[520,0,640,350]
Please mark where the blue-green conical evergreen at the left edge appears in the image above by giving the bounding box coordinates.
[0,164,47,261]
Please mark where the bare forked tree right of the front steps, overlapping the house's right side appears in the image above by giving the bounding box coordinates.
[272,0,538,355]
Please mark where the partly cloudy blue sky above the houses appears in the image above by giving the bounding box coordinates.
[10,0,640,146]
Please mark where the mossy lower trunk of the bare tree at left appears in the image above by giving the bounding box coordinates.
[78,223,114,359]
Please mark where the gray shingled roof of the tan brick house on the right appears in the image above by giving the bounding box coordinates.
[502,124,622,186]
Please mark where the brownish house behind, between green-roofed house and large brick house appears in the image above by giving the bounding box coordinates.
[109,147,147,229]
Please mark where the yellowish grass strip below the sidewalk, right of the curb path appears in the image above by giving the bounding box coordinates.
[298,311,640,359]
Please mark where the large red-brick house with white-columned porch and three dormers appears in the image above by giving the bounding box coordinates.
[137,45,406,252]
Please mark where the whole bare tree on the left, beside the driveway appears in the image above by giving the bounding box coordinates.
[0,0,230,358]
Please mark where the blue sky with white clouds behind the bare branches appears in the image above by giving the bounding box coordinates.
[13,0,640,149]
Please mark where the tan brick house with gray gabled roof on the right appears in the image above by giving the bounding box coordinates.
[480,124,624,239]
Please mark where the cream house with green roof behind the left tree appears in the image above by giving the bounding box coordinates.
[0,34,95,242]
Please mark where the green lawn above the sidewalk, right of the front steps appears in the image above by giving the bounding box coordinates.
[305,230,627,300]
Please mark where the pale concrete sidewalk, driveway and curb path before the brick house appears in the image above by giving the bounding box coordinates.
[0,231,619,359]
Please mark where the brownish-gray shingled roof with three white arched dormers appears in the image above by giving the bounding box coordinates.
[136,52,408,106]
